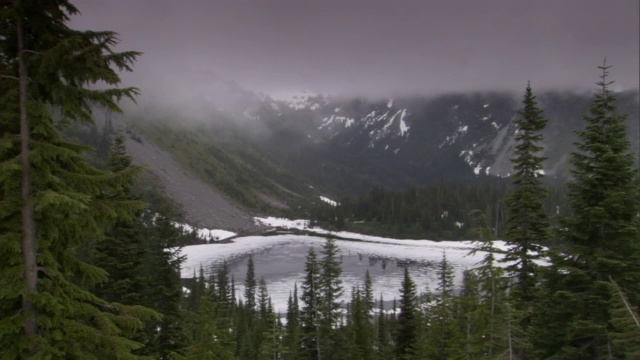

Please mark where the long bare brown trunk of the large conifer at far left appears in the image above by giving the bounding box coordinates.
[15,0,38,352]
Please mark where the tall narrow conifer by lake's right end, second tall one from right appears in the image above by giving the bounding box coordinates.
[503,84,549,303]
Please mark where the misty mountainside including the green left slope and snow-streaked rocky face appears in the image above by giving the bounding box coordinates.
[117,86,640,228]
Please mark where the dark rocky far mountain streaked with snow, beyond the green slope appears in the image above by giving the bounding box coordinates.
[212,87,639,194]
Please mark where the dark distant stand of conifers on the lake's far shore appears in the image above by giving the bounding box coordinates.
[311,183,508,240]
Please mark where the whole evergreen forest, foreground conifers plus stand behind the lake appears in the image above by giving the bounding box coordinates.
[0,0,640,360]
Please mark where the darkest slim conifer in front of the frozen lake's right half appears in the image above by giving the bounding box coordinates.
[395,267,420,359]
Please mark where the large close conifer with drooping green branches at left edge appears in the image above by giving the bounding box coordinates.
[0,0,158,359]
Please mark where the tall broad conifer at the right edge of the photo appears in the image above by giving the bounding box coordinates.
[536,63,640,359]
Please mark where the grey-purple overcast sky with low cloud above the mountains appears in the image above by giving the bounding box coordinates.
[72,0,640,100]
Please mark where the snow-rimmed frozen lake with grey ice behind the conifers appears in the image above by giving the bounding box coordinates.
[182,234,500,311]
